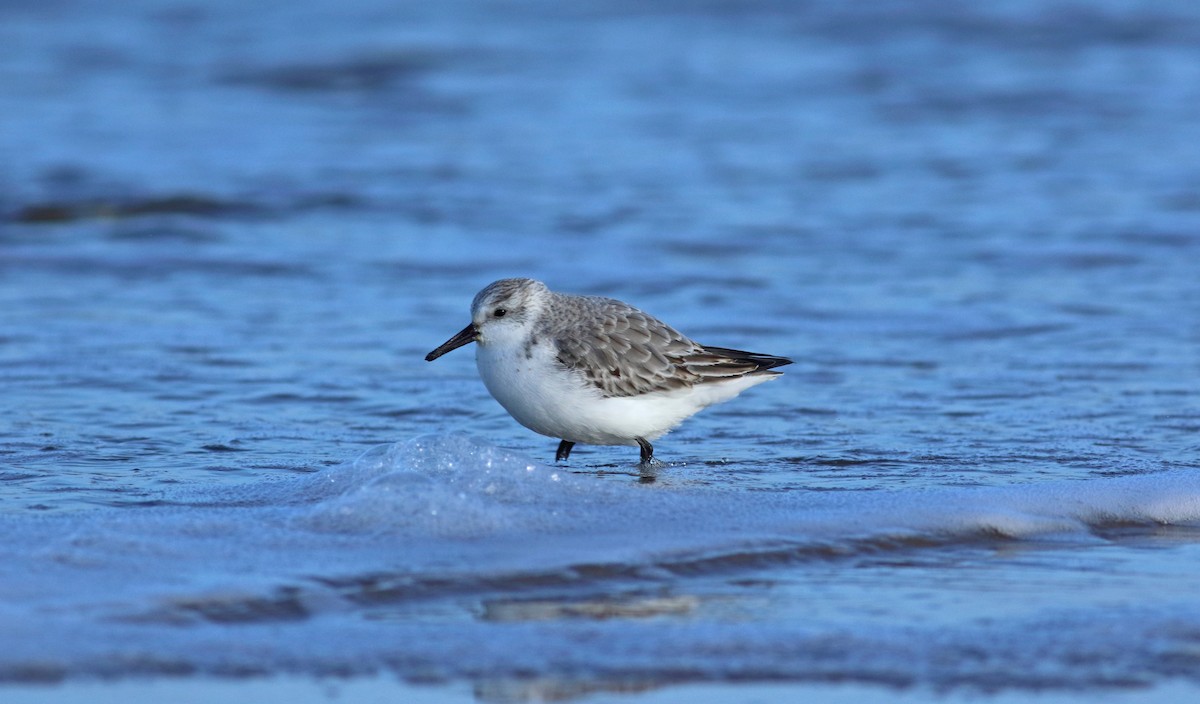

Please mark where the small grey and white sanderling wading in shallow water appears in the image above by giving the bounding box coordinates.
[425,278,792,467]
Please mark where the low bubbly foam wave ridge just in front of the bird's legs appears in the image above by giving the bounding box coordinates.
[246,437,1200,544]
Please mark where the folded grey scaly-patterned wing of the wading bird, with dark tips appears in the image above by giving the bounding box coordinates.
[545,295,791,397]
